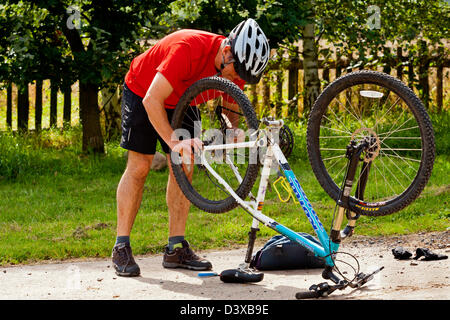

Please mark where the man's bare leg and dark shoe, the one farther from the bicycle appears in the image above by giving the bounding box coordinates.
[113,151,153,276]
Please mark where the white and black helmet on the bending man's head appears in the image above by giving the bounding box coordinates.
[228,18,270,84]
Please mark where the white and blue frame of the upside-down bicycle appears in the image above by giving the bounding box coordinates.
[201,120,339,267]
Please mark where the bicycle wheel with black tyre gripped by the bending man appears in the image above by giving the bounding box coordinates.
[171,77,259,213]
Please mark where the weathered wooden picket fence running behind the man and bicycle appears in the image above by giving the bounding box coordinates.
[0,48,450,130]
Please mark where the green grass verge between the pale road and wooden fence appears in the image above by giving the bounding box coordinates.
[0,119,450,265]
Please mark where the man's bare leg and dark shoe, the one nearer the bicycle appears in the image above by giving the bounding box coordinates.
[163,153,212,270]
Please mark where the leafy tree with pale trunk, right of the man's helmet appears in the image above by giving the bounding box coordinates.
[260,0,450,115]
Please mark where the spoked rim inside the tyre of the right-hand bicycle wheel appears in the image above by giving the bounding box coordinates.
[318,84,424,204]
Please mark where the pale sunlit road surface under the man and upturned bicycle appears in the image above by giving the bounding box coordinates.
[0,231,450,300]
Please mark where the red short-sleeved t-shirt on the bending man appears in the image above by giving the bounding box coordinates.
[125,29,245,109]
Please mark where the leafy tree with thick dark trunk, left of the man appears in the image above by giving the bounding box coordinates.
[2,0,171,153]
